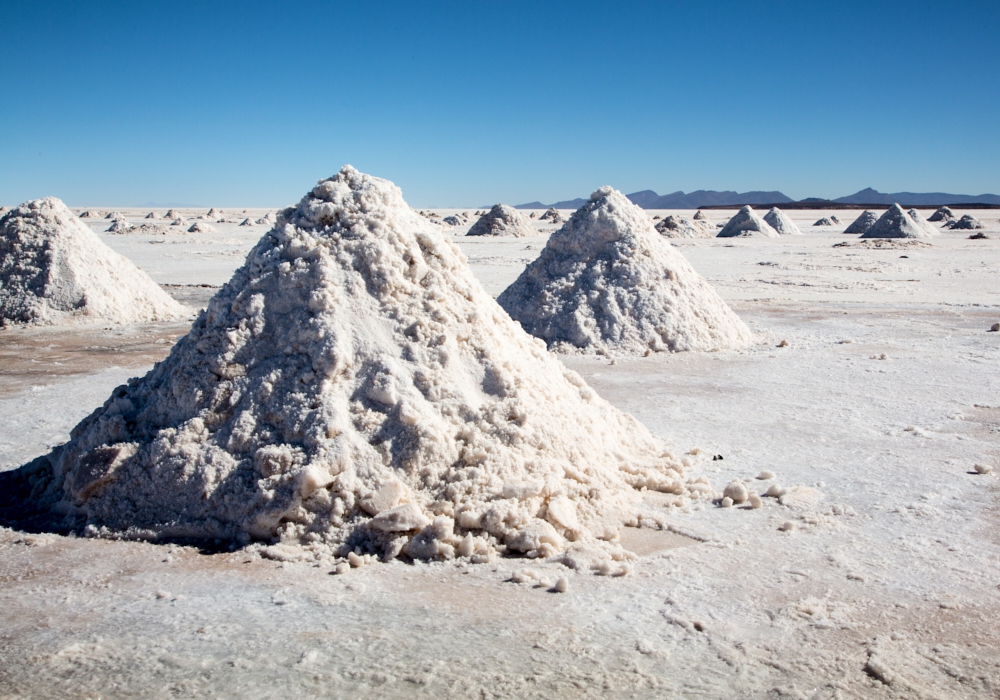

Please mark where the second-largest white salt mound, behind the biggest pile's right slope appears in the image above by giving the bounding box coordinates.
[497,187,753,354]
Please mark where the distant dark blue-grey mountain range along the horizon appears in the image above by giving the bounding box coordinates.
[514,187,1000,209]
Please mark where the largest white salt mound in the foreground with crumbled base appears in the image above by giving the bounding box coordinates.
[22,166,712,558]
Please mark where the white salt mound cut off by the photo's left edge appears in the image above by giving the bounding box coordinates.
[0,197,188,325]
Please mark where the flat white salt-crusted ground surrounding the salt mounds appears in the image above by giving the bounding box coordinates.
[0,205,1000,698]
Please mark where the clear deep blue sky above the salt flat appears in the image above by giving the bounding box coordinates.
[0,0,1000,207]
